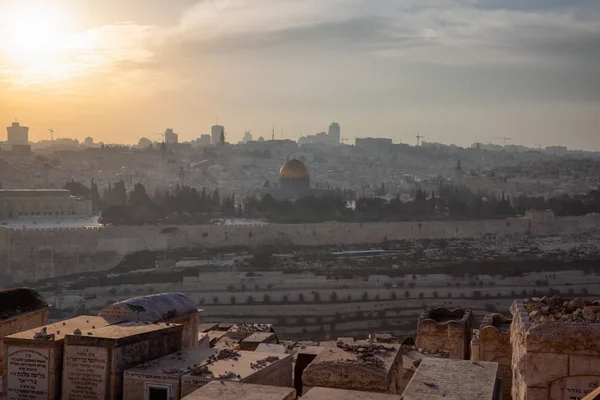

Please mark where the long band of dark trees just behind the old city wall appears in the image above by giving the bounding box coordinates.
[65,180,600,224]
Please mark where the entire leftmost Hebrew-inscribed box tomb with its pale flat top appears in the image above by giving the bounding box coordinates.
[4,315,110,400]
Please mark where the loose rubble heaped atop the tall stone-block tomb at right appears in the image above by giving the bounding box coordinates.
[523,296,600,325]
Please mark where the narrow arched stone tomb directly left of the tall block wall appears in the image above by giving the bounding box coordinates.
[471,313,512,400]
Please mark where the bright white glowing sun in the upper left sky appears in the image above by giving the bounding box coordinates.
[0,6,66,62]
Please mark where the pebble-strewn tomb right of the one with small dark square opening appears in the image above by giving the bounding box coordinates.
[181,350,292,396]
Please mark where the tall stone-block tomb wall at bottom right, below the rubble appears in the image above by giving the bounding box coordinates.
[510,301,600,400]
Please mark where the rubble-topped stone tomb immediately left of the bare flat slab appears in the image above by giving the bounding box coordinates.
[302,340,402,394]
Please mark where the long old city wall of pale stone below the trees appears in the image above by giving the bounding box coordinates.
[0,217,600,282]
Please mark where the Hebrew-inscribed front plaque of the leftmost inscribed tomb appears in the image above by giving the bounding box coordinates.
[6,346,48,400]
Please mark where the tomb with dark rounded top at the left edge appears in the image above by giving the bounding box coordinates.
[0,288,49,376]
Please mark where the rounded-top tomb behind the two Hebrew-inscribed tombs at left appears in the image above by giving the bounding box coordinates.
[98,293,199,347]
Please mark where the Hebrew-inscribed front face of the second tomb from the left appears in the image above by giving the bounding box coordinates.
[63,346,108,400]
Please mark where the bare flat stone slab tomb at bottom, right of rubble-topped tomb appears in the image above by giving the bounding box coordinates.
[402,358,502,400]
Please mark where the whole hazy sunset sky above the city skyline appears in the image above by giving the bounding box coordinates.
[0,0,600,150]
